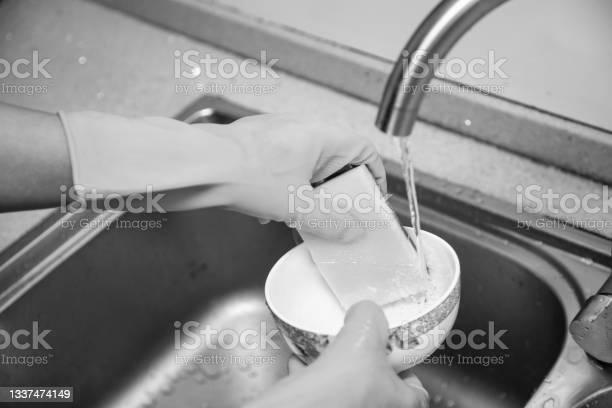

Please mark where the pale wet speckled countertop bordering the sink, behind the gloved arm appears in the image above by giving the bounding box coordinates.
[0,0,612,250]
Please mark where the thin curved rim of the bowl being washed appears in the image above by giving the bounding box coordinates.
[264,226,461,337]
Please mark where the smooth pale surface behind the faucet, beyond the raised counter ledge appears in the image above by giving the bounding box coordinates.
[215,0,612,129]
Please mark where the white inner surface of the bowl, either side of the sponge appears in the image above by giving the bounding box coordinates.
[266,231,458,335]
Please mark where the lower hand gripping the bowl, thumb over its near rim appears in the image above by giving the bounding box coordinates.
[246,301,429,408]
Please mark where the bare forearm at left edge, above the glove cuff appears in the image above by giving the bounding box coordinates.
[0,103,72,212]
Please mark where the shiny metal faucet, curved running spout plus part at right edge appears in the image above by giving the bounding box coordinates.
[376,0,612,363]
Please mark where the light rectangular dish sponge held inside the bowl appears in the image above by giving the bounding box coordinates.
[300,166,432,318]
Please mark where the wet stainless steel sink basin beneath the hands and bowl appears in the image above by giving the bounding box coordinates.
[0,98,612,408]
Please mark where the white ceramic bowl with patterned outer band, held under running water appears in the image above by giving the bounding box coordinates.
[265,231,460,372]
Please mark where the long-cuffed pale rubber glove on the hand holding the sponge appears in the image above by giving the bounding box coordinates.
[61,112,386,238]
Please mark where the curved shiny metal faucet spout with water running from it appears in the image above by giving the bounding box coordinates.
[376,0,506,136]
